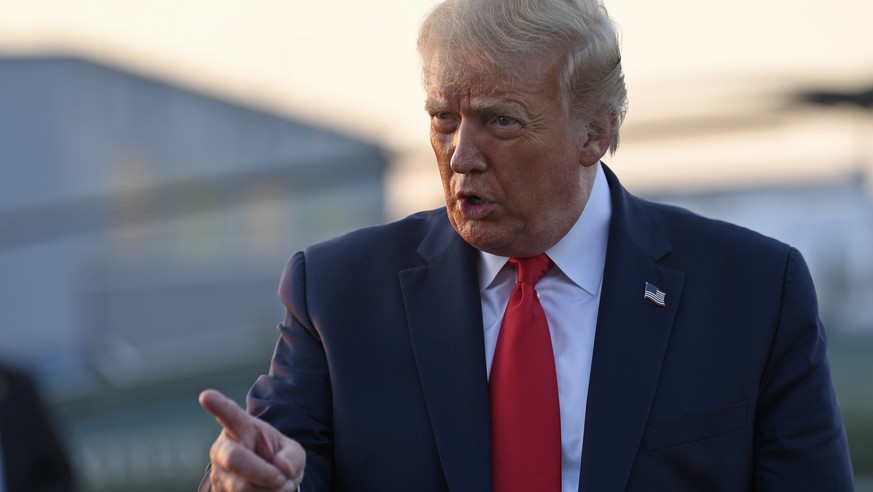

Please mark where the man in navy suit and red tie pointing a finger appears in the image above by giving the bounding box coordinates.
[201,0,852,492]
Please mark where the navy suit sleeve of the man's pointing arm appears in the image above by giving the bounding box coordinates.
[246,252,333,492]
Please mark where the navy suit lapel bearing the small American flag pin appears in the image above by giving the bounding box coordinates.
[580,166,685,491]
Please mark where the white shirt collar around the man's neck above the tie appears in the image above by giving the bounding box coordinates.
[479,162,612,296]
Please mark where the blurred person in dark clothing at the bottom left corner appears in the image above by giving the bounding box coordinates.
[0,365,74,492]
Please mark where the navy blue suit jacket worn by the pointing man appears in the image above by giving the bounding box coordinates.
[235,164,852,492]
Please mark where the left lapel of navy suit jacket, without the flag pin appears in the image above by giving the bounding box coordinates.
[400,215,491,492]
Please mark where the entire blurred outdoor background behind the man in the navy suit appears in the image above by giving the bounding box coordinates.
[0,0,873,492]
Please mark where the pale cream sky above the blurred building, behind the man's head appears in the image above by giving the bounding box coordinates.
[0,0,873,215]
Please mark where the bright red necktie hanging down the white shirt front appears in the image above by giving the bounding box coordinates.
[488,253,561,492]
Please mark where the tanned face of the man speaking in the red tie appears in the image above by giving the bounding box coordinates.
[426,57,605,257]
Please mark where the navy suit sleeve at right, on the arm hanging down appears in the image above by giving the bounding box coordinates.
[754,249,854,491]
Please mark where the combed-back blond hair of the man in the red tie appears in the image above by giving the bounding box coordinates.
[418,0,627,152]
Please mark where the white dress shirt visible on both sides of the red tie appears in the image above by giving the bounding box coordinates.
[479,163,612,492]
